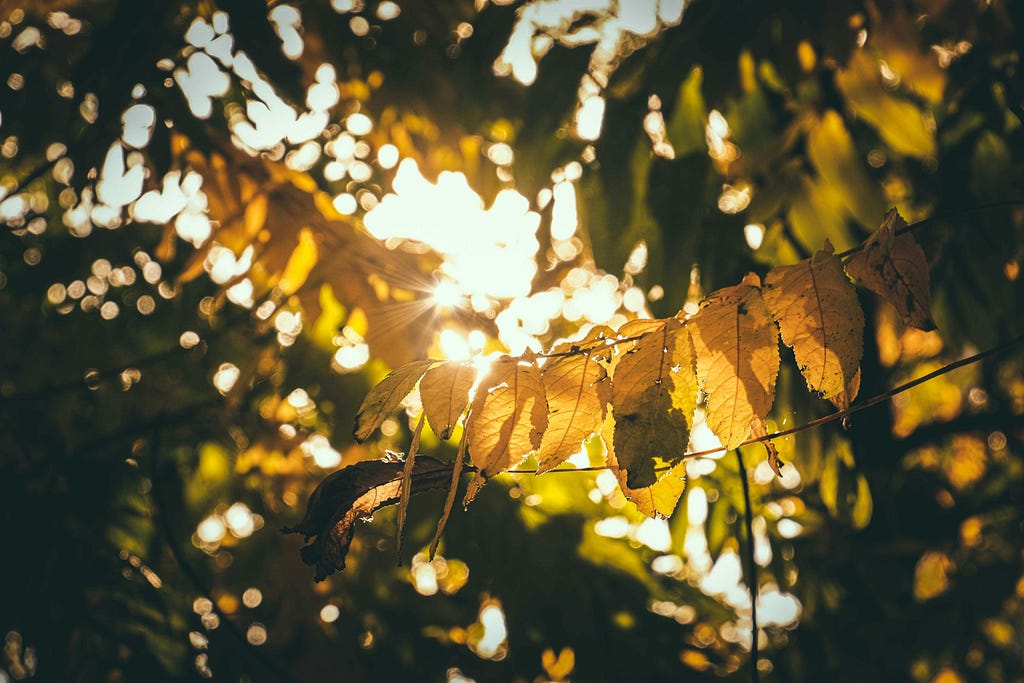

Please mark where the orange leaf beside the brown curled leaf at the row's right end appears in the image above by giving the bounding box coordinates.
[762,240,864,398]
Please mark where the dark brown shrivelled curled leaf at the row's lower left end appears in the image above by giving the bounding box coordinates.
[282,456,452,582]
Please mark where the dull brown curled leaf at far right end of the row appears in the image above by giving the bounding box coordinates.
[846,209,935,331]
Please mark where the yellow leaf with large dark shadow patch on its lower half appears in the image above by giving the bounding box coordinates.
[611,318,697,488]
